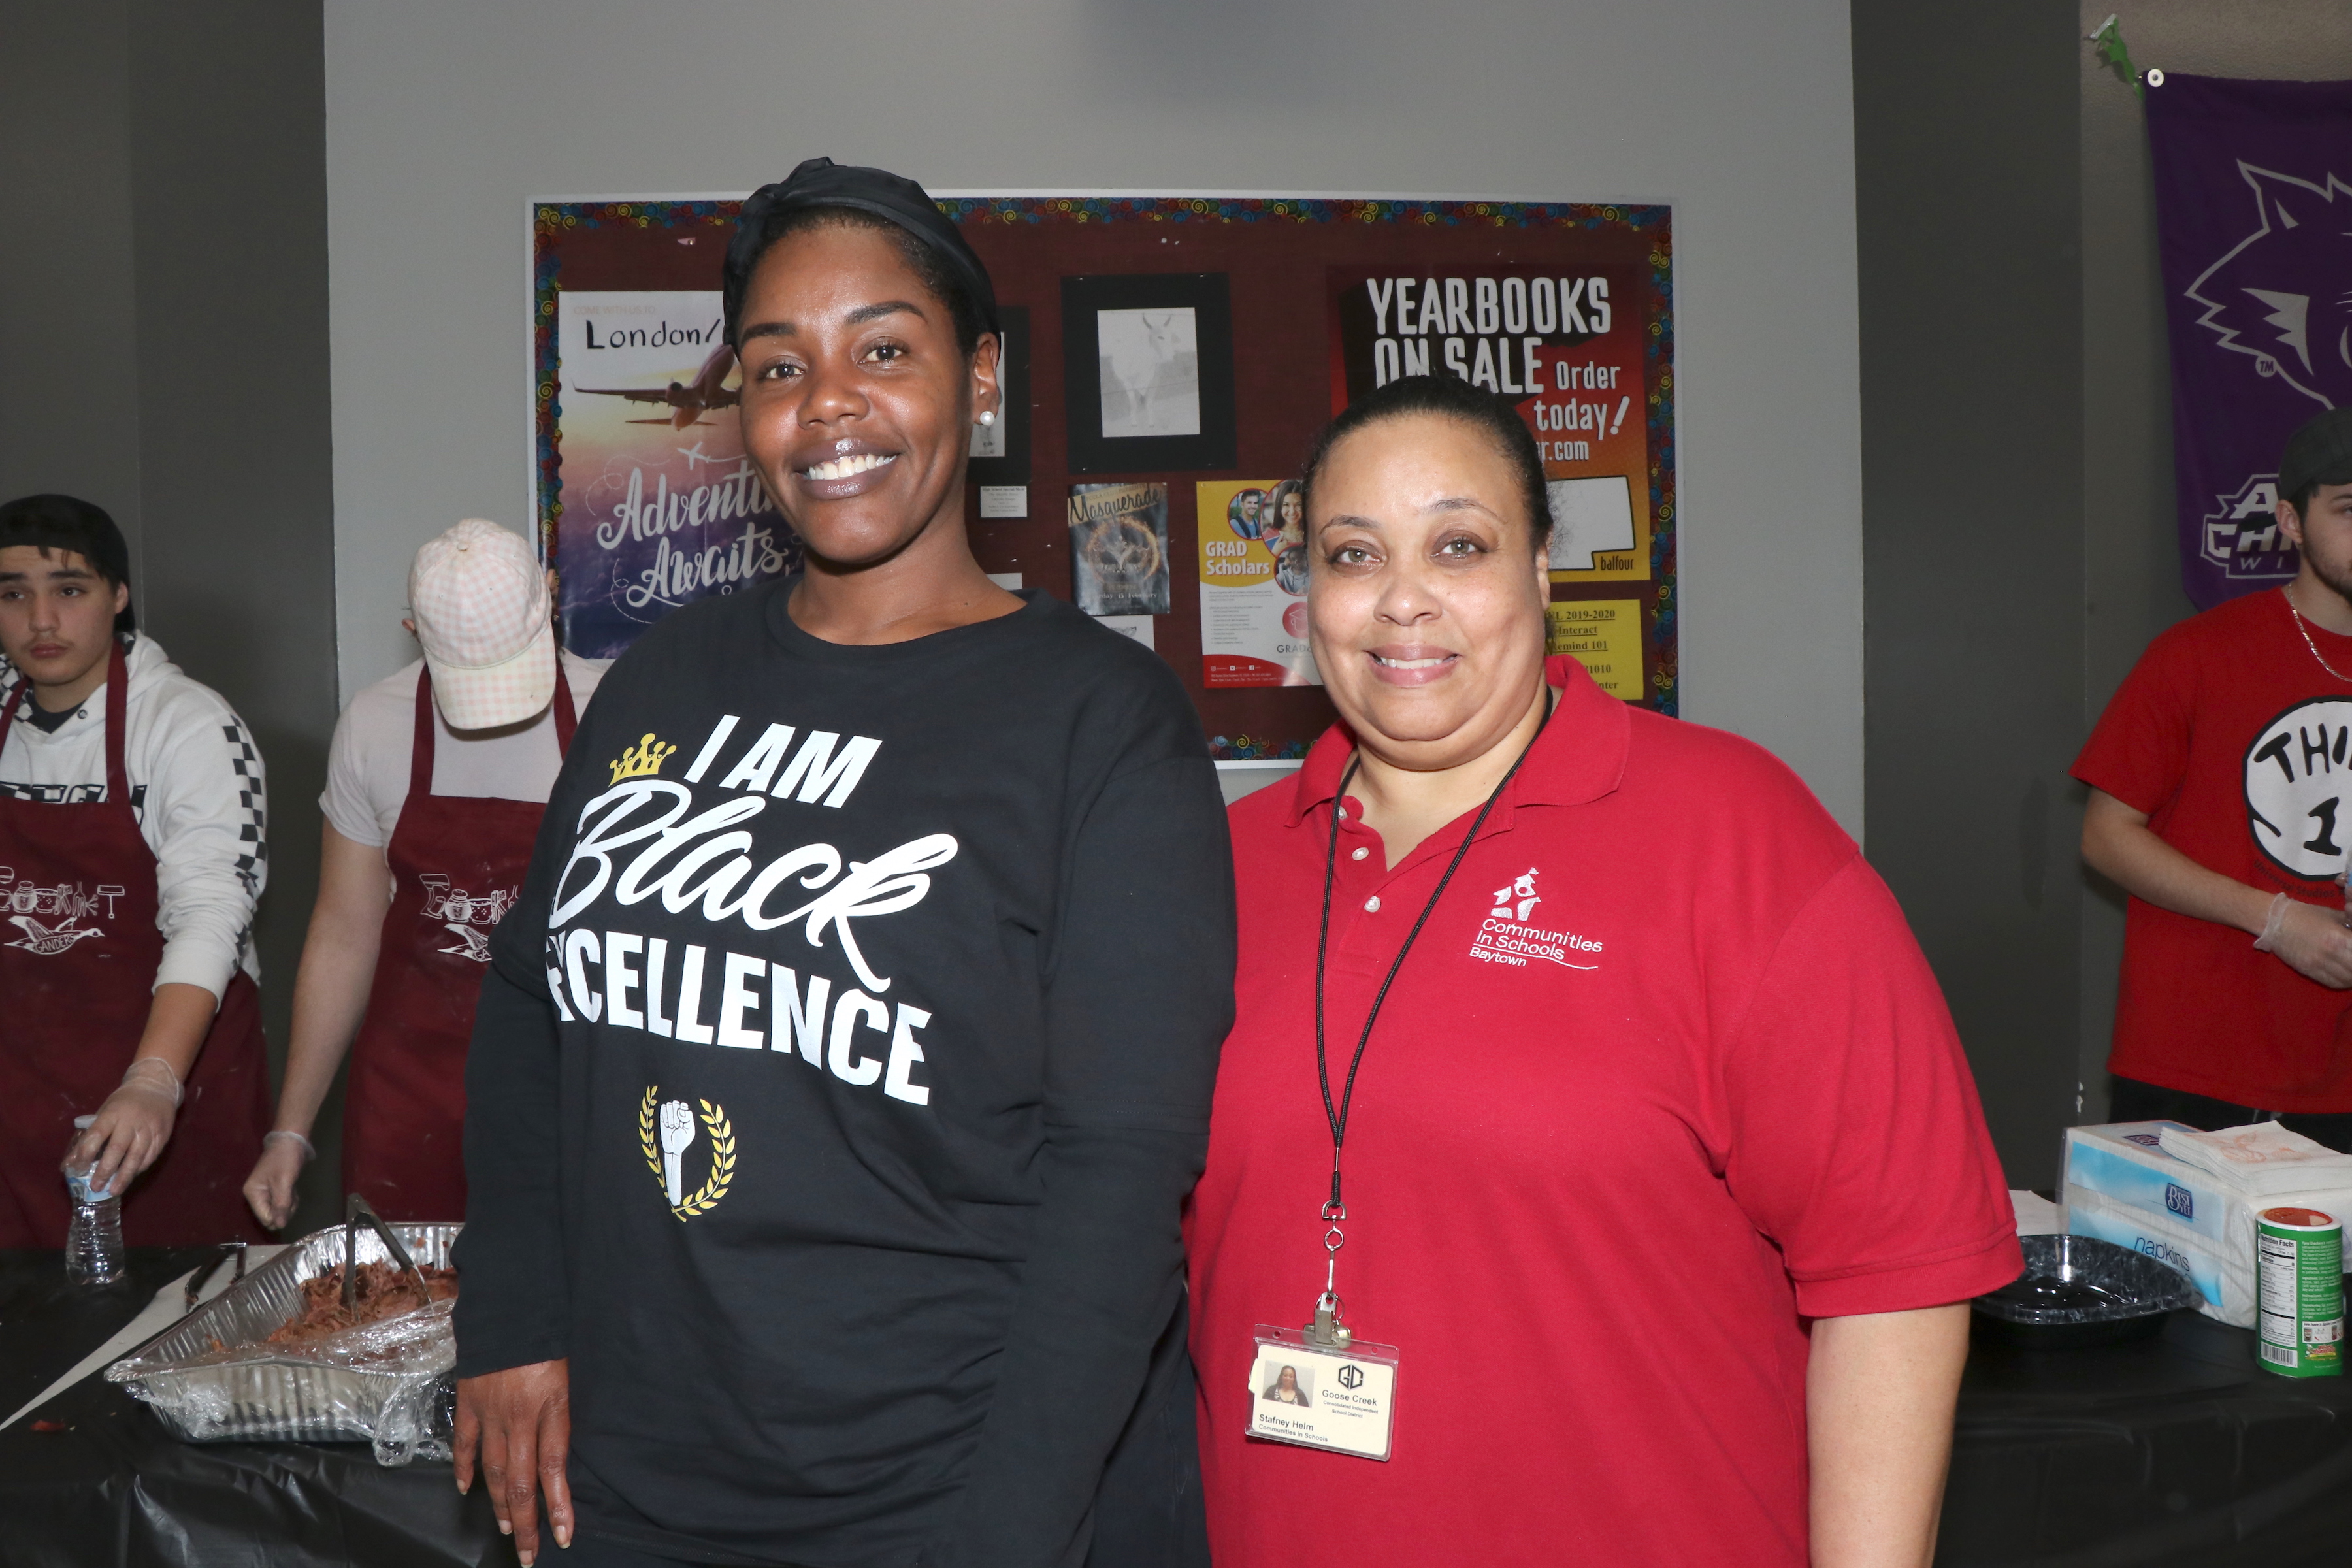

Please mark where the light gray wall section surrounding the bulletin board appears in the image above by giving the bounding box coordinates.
[327,0,1863,832]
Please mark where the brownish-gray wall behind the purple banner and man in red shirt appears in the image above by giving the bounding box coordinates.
[2065,0,2352,1121]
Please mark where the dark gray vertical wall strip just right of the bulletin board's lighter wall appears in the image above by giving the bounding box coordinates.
[1854,0,2082,1187]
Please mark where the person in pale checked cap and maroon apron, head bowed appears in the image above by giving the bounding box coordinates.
[244,519,597,1230]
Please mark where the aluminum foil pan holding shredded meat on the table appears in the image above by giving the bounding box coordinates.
[106,1225,461,1465]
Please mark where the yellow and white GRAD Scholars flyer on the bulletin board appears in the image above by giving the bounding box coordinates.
[1195,480,1322,687]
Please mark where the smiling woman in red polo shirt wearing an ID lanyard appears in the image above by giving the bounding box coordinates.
[1188,376,2020,1568]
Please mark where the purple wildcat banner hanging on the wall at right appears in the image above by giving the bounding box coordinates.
[2148,75,2352,609]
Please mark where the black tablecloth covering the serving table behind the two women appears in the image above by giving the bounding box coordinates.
[0,1250,2352,1568]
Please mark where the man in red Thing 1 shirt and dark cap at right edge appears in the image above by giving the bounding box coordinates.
[2074,409,2352,1150]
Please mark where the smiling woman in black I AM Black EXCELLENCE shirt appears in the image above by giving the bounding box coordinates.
[456,160,1232,1568]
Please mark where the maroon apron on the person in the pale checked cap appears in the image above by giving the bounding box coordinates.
[344,661,574,1222]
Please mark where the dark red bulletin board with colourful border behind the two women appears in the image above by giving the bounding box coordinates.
[532,195,1677,759]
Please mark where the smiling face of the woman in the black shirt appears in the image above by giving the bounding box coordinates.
[738,223,997,569]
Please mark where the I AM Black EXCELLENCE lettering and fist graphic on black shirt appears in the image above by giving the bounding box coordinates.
[546,715,957,1114]
